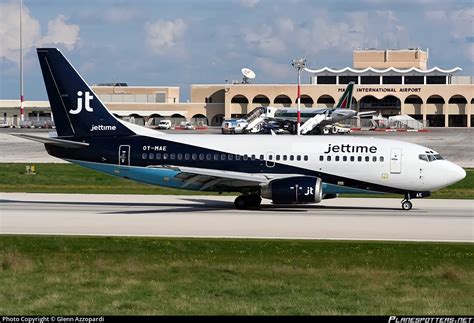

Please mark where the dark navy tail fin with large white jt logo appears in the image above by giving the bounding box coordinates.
[37,48,134,138]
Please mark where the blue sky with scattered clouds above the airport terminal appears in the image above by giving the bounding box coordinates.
[0,0,474,102]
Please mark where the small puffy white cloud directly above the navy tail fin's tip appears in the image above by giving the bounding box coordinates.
[40,15,79,50]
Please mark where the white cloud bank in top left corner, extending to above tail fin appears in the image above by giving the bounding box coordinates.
[0,2,79,63]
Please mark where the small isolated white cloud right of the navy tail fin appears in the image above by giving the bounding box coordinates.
[145,19,186,54]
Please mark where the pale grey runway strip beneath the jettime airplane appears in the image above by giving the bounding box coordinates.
[0,193,474,242]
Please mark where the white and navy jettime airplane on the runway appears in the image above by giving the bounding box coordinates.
[15,48,466,210]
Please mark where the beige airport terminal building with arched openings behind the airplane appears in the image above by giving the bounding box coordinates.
[0,48,474,127]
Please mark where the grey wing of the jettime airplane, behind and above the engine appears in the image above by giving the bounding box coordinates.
[150,165,301,191]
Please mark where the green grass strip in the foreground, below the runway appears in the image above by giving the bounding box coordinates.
[0,236,474,315]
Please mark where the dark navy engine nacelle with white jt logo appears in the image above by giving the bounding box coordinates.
[261,176,323,204]
